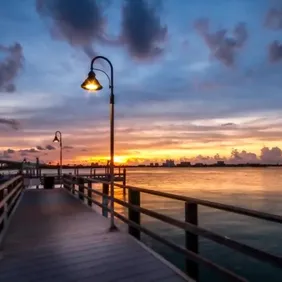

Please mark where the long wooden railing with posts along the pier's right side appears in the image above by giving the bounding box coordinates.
[63,175,282,281]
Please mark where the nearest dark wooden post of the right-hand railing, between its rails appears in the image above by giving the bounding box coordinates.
[185,202,199,281]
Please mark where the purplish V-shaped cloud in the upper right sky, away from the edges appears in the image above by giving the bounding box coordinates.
[194,18,248,67]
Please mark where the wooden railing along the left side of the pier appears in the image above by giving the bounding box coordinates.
[0,175,24,239]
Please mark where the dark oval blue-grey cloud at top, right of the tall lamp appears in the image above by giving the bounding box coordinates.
[121,0,167,59]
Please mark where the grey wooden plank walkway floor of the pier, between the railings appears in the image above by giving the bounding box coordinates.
[0,189,189,282]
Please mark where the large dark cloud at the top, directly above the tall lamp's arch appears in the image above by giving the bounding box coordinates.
[36,0,105,57]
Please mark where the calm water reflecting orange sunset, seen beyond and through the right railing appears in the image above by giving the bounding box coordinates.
[4,168,282,282]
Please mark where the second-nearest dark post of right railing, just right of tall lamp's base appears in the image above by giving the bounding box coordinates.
[128,189,141,240]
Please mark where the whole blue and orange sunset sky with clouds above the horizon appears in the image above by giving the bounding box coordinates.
[0,0,282,164]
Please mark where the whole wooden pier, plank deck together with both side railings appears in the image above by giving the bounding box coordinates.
[0,173,282,282]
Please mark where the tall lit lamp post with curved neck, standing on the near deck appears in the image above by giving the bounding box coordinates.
[81,56,116,231]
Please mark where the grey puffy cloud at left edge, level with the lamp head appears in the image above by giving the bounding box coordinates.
[0,43,24,92]
